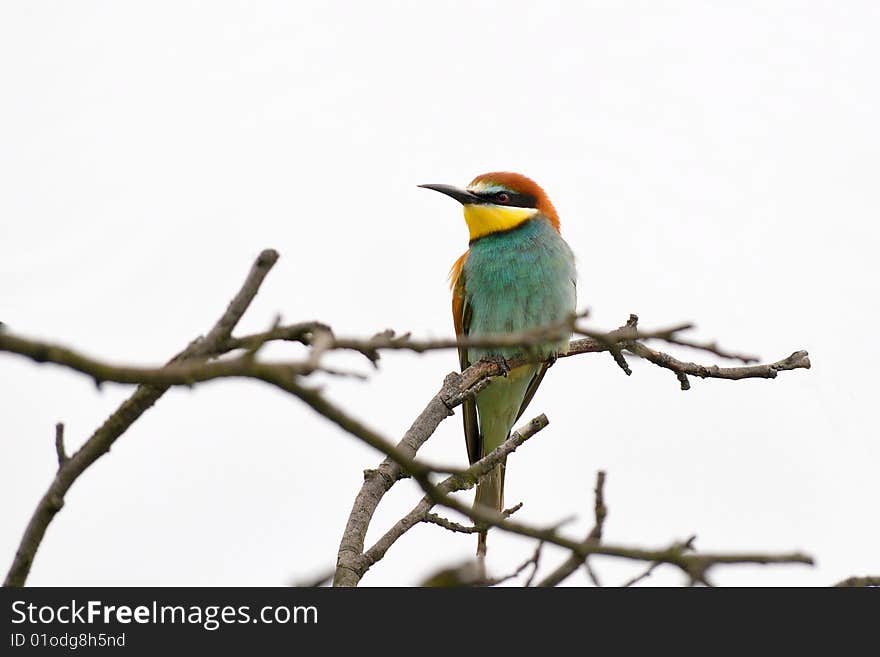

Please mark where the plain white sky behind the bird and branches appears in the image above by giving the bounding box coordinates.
[0,2,880,585]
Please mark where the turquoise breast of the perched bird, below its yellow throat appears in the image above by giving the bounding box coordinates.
[463,215,577,363]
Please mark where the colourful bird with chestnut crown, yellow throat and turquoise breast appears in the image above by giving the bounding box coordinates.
[419,171,577,557]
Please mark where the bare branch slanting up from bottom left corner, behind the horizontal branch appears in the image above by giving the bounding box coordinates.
[0,249,278,586]
